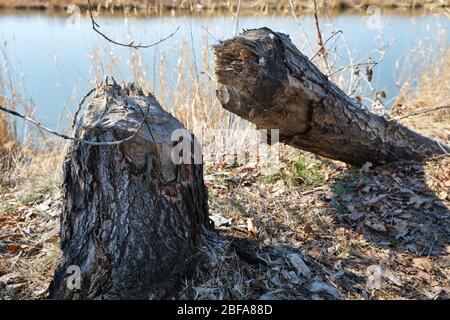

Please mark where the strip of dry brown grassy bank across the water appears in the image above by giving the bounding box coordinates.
[0,0,450,11]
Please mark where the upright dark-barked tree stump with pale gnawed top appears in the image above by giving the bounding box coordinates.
[49,84,212,299]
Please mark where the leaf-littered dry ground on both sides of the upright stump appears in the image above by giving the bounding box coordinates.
[0,150,450,300]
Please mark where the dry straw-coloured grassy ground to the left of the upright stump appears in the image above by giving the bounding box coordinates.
[0,147,64,299]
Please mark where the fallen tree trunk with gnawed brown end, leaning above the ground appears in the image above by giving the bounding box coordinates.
[215,28,450,165]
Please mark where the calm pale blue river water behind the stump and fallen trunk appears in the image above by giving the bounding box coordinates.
[0,11,450,128]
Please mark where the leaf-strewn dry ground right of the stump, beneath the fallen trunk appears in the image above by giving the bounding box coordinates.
[179,153,450,299]
